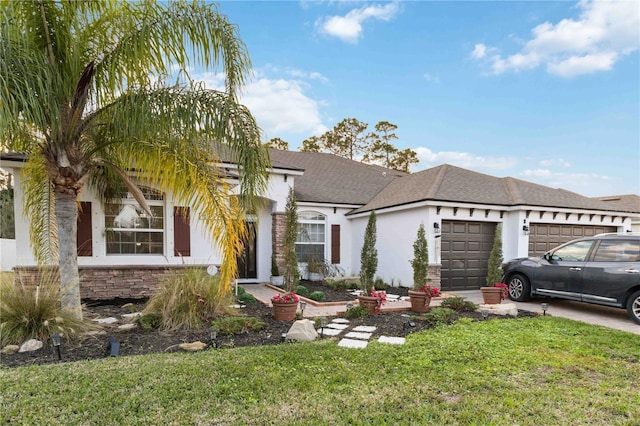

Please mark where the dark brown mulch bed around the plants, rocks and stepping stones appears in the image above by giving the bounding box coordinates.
[0,282,534,368]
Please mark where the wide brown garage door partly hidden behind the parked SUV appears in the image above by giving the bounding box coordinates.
[529,223,617,256]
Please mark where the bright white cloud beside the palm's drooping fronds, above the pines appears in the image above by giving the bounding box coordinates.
[194,70,327,139]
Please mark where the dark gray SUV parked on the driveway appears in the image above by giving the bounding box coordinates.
[502,233,640,324]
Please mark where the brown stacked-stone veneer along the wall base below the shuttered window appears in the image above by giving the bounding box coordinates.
[14,265,206,300]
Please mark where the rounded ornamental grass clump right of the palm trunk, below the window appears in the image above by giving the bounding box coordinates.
[143,268,233,330]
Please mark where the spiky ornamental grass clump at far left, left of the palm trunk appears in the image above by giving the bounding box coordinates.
[0,273,98,346]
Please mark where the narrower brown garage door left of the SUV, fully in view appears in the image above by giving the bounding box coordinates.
[441,221,496,290]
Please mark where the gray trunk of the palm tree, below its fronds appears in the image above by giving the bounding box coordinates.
[55,192,82,319]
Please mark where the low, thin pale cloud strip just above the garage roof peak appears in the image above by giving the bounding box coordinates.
[413,147,517,172]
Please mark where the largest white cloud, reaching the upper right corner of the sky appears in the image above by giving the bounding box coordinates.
[471,0,640,77]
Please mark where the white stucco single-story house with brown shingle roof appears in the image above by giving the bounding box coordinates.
[2,150,640,299]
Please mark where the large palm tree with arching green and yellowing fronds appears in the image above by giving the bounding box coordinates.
[0,0,269,318]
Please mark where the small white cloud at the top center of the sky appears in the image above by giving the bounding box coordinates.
[316,2,400,43]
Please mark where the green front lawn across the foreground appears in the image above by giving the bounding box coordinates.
[0,316,640,425]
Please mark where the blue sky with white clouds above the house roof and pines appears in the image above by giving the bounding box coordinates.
[198,1,640,196]
